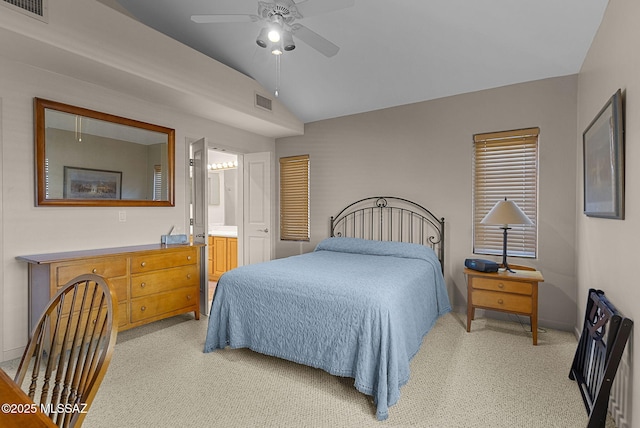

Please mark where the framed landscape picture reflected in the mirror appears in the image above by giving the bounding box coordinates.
[63,166,122,199]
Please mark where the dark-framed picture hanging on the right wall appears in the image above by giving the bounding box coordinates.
[582,89,624,220]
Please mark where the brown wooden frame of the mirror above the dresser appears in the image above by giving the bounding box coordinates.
[34,98,175,207]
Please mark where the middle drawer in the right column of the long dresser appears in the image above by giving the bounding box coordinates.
[131,265,200,297]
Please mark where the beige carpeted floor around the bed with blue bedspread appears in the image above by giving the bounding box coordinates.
[2,313,613,428]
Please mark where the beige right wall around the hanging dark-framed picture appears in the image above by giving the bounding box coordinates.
[576,0,640,426]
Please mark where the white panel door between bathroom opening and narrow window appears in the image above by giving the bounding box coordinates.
[243,152,272,264]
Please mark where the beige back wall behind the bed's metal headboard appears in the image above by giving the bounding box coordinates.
[276,75,577,330]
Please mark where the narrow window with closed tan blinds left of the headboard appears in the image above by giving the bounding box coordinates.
[280,155,309,241]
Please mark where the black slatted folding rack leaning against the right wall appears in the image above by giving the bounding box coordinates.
[569,289,633,428]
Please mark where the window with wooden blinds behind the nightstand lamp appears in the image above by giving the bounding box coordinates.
[473,128,540,258]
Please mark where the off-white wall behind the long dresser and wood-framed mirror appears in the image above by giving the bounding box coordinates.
[0,63,275,361]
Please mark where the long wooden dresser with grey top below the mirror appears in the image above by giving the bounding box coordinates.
[17,244,202,333]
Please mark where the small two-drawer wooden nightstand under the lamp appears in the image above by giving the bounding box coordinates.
[464,266,544,345]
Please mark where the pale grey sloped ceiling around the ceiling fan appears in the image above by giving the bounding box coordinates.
[99,0,608,123]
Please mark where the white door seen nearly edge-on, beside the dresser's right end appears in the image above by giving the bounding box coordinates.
[191,138,209,315]
